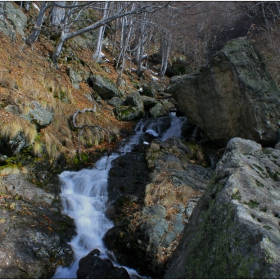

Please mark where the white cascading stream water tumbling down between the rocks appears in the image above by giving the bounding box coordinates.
[53,116,186,278]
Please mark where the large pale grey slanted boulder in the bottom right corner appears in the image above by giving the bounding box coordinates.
[164,138,280,278]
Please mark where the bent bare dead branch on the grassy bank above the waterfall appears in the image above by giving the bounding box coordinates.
[73,105,110,165]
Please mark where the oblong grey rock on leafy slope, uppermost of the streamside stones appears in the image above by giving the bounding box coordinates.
[89,75,122,99]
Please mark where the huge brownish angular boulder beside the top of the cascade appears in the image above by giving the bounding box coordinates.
[166,38,280,145]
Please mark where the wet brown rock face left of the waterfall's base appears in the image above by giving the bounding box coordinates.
[0,174,74,278]
